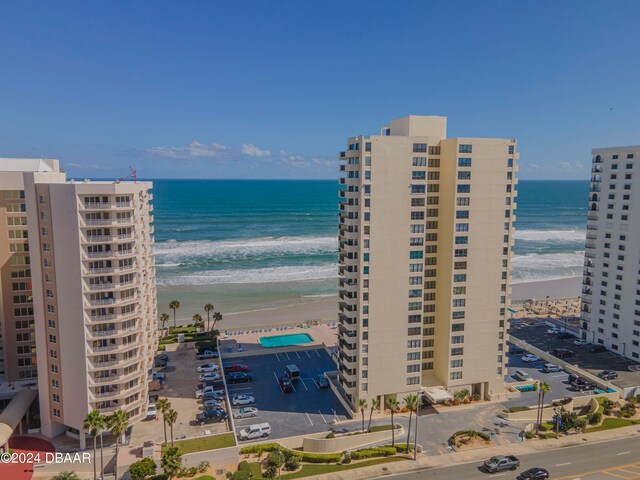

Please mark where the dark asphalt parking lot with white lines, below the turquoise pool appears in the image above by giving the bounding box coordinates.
[223,349,347,438]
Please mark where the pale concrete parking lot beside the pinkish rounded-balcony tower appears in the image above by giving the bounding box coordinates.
[132,347,229,442]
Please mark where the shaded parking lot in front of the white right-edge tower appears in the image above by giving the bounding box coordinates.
[509,323,640,388]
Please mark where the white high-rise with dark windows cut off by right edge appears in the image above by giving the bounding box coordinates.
[580,146,640,361]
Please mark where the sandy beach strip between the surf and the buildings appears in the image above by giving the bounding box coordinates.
[158,277,582,331]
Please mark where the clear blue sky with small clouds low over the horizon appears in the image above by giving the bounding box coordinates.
[0,0,640,179]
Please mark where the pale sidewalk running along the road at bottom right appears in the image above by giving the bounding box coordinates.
[304,425,640,480]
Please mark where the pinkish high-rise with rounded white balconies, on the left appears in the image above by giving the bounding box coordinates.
[0,159,157,448]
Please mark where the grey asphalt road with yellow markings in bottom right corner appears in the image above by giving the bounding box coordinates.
[380,437,640,480]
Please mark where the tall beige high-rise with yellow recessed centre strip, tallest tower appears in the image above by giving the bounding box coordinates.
[338,116,518,407]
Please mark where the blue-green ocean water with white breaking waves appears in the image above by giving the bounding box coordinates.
[154,180,589,310]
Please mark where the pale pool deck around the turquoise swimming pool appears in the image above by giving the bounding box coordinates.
[220,323,338,353]
